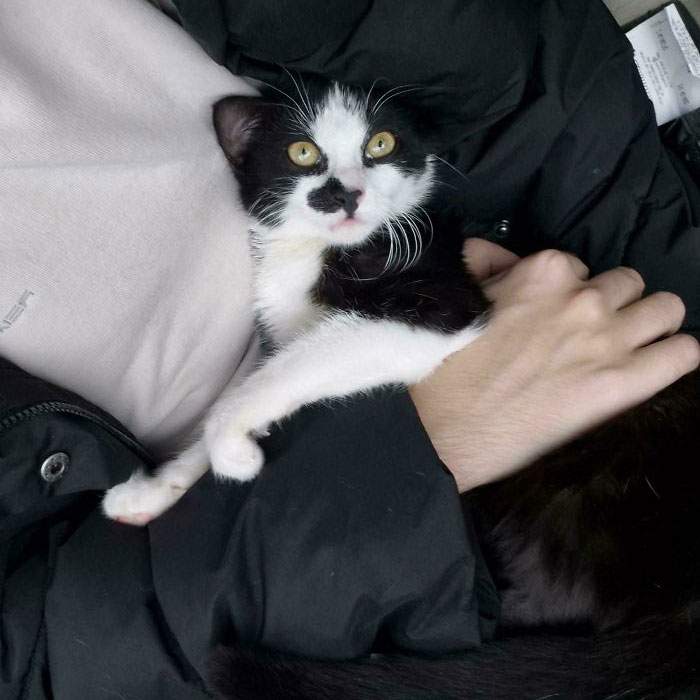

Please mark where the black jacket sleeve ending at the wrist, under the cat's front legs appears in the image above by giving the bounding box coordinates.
[150,391,499,665]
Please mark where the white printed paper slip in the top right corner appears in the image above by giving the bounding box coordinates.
[627,5,700,125]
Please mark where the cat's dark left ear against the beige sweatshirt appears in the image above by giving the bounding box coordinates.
[214,95,279,168]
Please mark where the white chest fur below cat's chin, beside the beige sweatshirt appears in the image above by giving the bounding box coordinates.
[253,232,326,344]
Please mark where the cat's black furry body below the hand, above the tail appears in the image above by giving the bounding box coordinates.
[467,372,700,632]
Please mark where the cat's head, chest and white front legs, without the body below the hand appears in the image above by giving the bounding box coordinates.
[103,84,488,525]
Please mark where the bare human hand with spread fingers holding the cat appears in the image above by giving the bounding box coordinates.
[410,239,700,491]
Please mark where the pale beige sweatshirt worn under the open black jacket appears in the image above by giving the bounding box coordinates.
[0,0,260,456]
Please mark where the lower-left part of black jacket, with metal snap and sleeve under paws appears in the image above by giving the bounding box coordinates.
[0,352,499,700]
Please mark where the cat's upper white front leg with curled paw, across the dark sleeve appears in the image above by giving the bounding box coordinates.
[204,313,482,481]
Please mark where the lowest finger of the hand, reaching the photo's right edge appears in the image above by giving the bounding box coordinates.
[624,334,700,403]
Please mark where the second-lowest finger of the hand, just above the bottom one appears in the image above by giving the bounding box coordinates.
[614,292,685,348]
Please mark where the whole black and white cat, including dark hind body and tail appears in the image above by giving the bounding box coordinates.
[103,80,700,700]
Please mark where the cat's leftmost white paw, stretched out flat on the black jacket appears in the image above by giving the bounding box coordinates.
[102,474,186,526]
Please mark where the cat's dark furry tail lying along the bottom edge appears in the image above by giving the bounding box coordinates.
[209,604,700,700]
